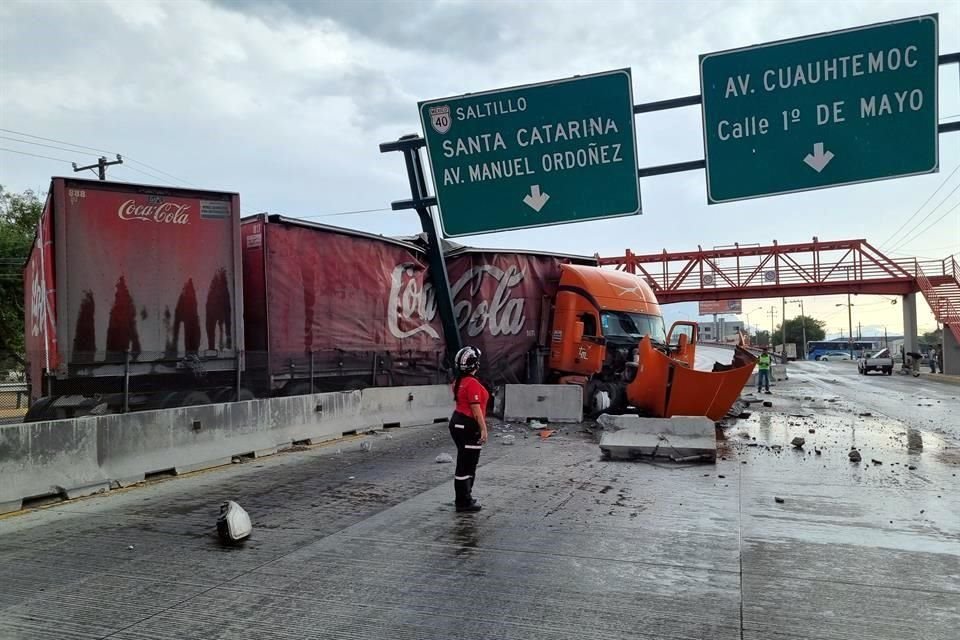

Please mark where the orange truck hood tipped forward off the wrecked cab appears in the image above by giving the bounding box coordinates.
[627,340,756,422]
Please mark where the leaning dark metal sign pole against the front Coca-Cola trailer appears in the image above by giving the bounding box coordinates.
[380,134,463,362]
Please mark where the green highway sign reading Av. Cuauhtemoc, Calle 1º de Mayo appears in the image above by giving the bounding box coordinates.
[700,14,939,204]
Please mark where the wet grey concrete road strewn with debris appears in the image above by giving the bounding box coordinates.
[0,363,960,640]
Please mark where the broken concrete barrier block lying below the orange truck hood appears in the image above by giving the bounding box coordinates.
[598,416,717,462]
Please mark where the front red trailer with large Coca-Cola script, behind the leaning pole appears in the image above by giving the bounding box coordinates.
[241,214,595,394]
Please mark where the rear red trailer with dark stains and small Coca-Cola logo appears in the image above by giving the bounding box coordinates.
[24,178,243,420]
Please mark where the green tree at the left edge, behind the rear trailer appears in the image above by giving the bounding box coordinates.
[0,186,43,373]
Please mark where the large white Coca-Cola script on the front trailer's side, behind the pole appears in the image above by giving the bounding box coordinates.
[387,264,526,339]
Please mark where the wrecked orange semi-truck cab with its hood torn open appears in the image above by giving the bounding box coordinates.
[549,265,755,420]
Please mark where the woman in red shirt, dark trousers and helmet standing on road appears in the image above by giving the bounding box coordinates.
[450,347,490,511]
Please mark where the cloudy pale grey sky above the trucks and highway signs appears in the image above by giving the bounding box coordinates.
[0,0,960,334]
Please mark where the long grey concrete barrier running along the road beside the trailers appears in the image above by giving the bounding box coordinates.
[0,385,453,514]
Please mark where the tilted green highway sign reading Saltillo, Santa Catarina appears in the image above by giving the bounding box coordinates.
[419,69,640,236]
